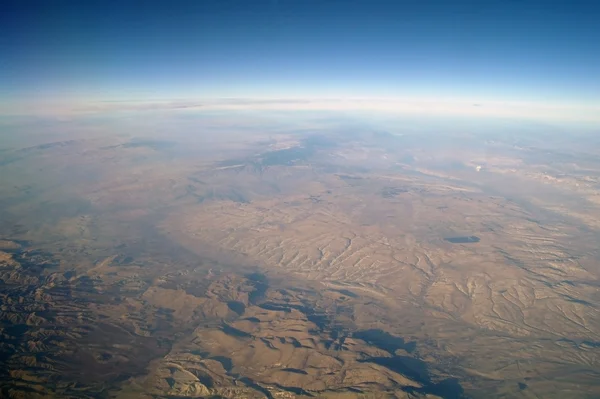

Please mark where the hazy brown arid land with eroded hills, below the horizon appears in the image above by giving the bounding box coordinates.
[0,112,600,398]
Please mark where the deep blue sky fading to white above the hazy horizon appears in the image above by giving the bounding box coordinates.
[0,0,600,122]
